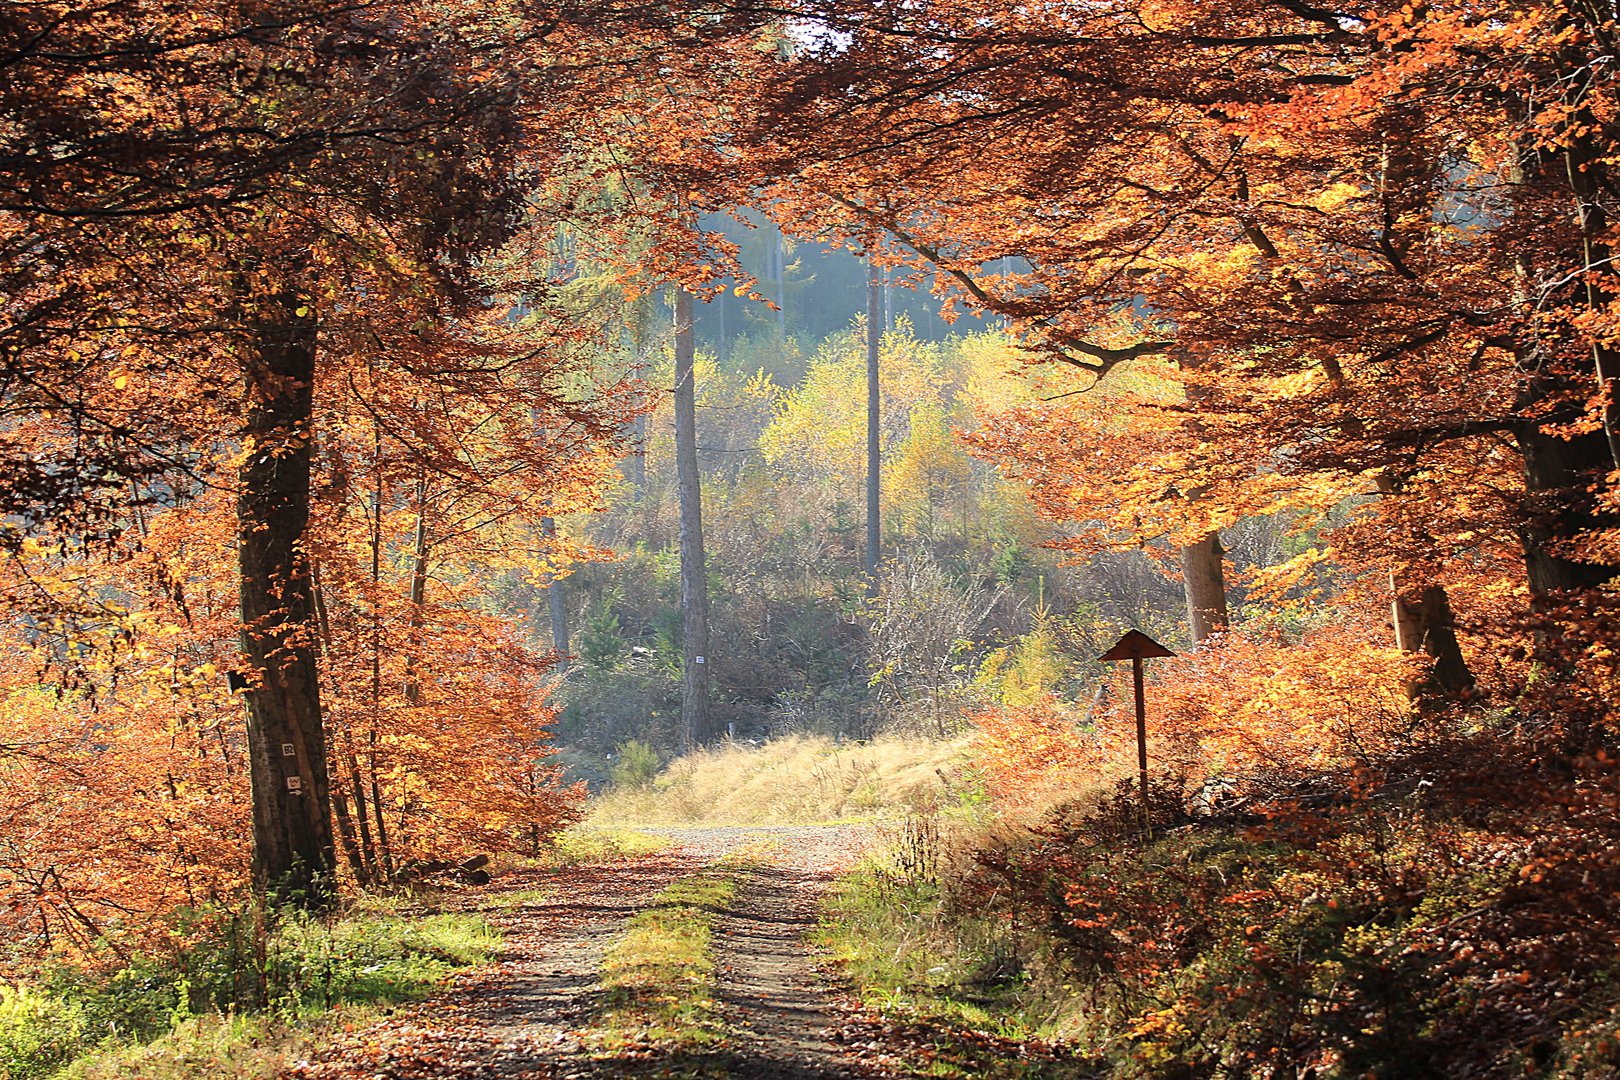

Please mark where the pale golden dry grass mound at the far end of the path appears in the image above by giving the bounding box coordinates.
[586,735,974,827]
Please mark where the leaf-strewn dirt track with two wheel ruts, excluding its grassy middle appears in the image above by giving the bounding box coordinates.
[287,826,880,1080]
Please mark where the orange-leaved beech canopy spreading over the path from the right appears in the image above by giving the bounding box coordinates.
[732,0,1620,682]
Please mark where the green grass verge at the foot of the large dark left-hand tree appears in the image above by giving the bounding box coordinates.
[0,899,499,1080]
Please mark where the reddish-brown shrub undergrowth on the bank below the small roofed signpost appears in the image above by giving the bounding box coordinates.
[821,743,1620,1080]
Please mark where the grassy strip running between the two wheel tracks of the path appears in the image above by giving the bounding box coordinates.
[595,860,744,1054]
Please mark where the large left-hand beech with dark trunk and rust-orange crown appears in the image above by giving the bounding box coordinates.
[0,0,774,905]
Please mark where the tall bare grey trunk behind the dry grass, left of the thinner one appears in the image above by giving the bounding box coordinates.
[676,293,710,750]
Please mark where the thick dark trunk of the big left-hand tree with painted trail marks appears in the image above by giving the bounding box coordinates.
[237,290,335,910]
